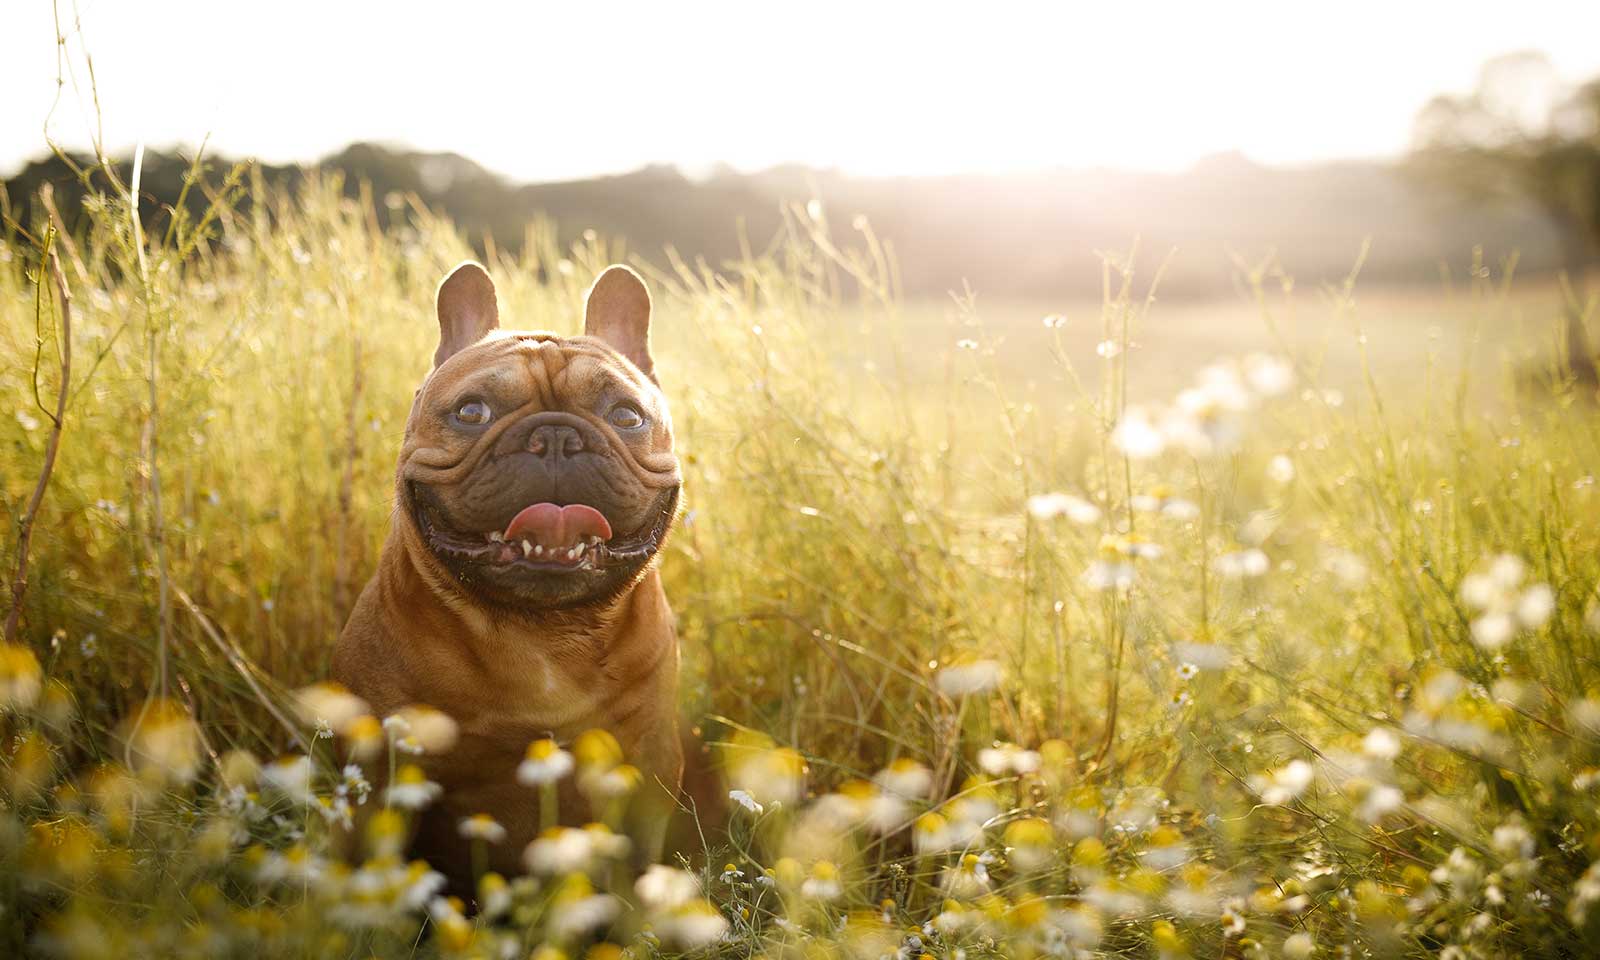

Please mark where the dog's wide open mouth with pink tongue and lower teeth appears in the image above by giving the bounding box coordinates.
[411,485,677,573]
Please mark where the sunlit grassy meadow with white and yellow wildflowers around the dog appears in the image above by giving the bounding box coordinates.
[0,171,1600,960]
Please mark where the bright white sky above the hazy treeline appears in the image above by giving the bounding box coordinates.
[0,0,1600,179]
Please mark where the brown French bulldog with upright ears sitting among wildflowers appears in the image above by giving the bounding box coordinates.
[333,262,683,878]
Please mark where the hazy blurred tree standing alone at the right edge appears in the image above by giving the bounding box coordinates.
[1413,51,1600,384]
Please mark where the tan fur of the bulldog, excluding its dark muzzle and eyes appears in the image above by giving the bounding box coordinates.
[333,270,683,877]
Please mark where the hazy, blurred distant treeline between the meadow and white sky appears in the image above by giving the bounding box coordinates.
[5,144,1560,296]
